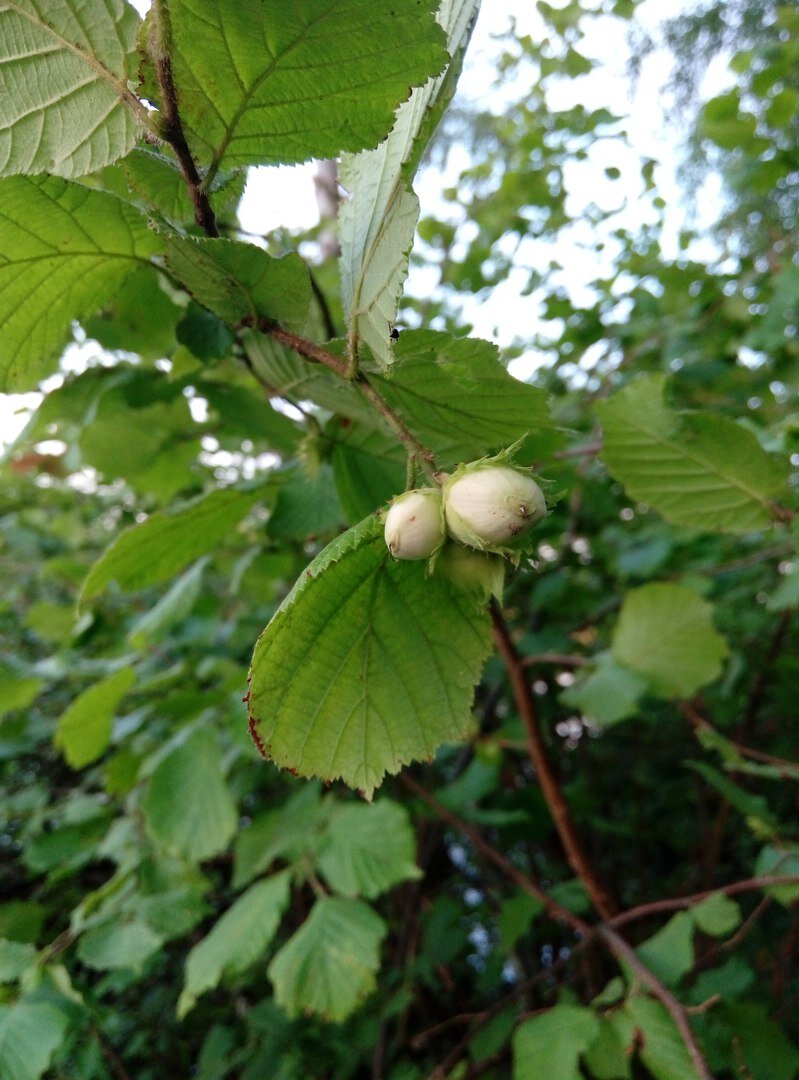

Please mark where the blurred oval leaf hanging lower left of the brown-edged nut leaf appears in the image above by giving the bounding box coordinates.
[141,729,239,862]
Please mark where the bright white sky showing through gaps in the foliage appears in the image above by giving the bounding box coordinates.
[0,0,724,446]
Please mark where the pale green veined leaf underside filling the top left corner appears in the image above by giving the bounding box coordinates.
[0,0,146,177]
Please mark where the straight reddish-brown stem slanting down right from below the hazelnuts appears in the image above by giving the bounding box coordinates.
[491,603,615,920]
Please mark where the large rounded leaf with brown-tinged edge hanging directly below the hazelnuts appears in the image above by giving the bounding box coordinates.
[249,516,490,797]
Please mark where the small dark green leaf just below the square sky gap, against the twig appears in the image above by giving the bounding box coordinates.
[165,237,311,328]
